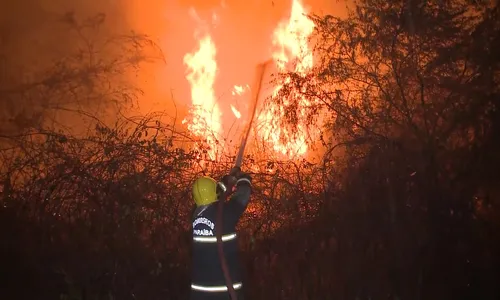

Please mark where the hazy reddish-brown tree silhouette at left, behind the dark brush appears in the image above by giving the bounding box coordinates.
[0,13,163,135]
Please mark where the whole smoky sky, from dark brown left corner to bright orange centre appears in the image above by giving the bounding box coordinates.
[0,0,350,136]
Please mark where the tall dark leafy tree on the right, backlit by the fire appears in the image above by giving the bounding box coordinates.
[272,0,499,299]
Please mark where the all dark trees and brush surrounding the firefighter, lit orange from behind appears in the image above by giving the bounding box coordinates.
[0,0,500,300]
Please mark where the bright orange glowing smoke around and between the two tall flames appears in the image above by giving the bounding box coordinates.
[127,0,344,116]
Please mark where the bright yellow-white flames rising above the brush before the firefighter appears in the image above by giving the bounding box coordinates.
[183,0,314,159]
